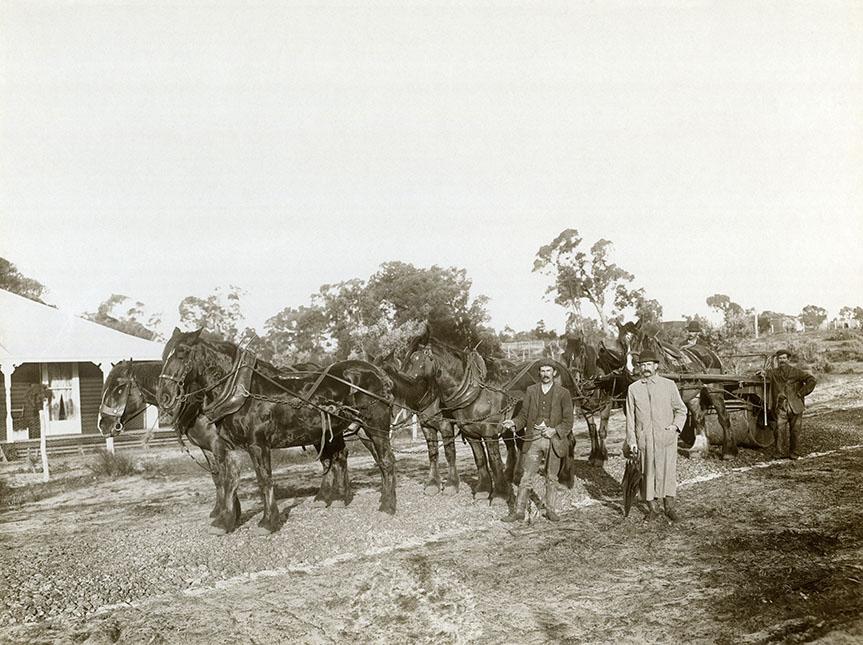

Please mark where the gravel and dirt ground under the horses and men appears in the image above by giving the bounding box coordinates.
[0,378,863,643]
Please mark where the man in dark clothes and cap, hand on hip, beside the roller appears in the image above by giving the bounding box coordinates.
[767,349,815,459]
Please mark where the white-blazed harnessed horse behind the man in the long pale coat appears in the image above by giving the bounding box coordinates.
[618,320,737,457]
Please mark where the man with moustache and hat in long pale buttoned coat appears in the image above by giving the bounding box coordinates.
[626,350,686,521]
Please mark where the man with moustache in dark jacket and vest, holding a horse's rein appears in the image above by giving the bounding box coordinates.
[501,360,572,522]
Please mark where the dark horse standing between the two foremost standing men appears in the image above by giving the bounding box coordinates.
[562,333,632,468]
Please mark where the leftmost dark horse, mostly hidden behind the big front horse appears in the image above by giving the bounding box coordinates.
[98,361,240,517]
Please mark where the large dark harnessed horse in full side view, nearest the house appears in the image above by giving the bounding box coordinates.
[159,329,396,532]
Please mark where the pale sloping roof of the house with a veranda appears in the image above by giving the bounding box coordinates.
[0,289,162,365]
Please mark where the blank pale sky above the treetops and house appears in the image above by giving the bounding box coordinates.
[0,0,863,338]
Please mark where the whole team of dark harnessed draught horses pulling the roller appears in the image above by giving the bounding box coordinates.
[99,316,736,534]
